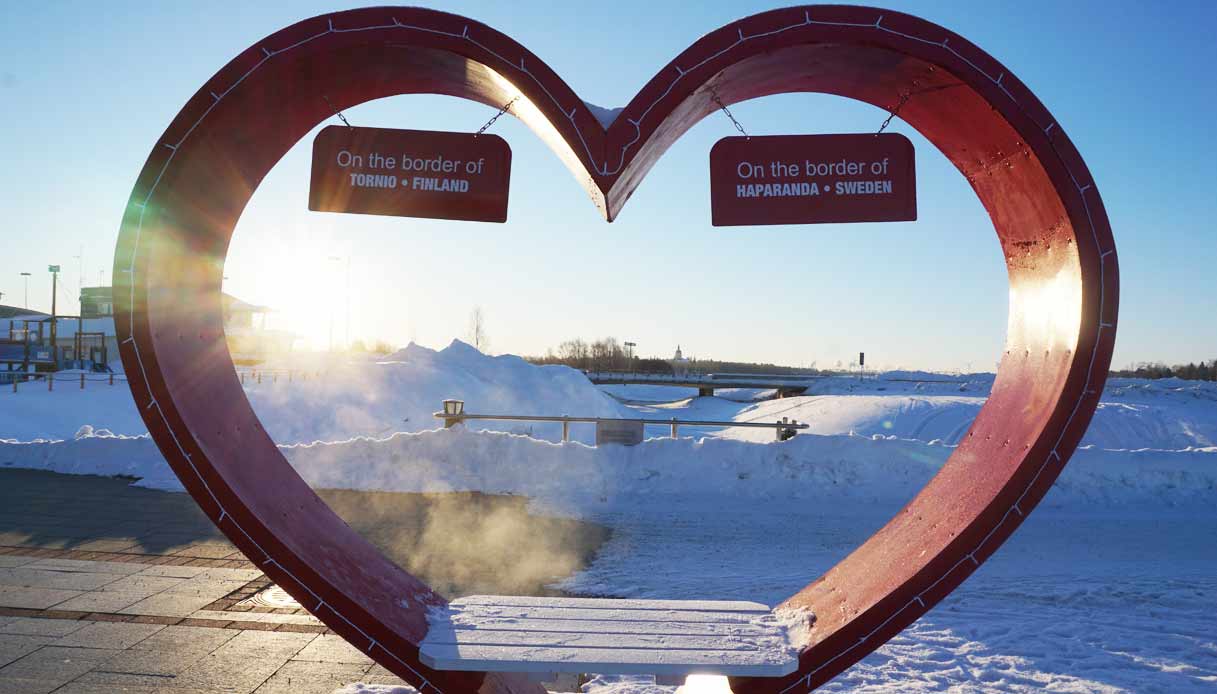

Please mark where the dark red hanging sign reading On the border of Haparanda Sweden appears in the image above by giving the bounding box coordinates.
[710,133,916,226]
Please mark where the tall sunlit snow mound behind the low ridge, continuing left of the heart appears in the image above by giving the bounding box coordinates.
[0,341,630,443]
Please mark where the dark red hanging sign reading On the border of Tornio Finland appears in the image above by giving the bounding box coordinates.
[308,125,511,222]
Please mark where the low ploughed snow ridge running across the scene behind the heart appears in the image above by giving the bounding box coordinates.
[7,427,1217,504]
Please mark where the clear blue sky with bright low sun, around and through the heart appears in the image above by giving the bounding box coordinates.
[0,0,1217,370]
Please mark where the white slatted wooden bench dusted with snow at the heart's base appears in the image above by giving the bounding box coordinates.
[419,595,808,677]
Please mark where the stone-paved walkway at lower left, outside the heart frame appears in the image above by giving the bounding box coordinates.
[0,470,400,694]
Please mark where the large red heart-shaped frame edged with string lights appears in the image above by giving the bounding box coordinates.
[113,6,1118,693]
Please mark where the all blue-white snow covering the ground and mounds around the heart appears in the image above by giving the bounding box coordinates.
[0,343,1217,694]
